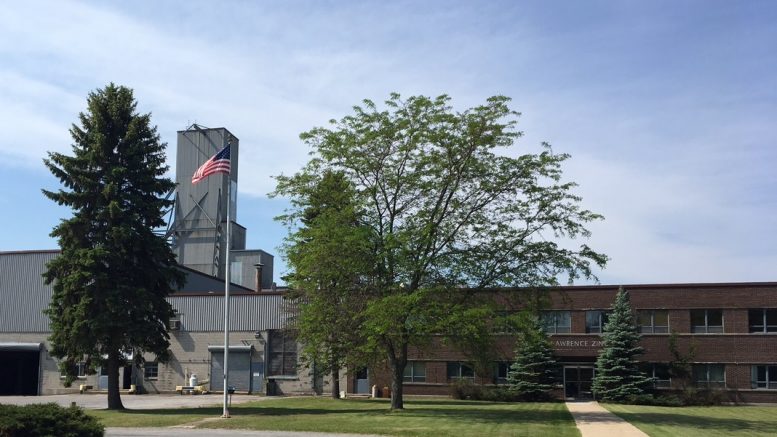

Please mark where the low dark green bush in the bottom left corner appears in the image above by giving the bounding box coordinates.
[0,403,105,437]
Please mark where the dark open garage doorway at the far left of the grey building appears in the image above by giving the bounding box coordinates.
[0,343,41,396]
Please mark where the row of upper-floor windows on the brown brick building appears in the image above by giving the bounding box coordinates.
[541,308,777,334]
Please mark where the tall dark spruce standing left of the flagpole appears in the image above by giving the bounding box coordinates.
[43,84,183,409]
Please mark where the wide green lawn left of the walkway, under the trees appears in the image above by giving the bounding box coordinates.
[89,398,580,437]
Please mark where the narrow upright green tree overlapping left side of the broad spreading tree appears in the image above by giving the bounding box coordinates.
[278,171,374,399]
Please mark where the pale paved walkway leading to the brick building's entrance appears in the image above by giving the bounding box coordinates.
[567,401,648,437]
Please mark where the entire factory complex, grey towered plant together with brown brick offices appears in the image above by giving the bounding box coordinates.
[0,125,777,402]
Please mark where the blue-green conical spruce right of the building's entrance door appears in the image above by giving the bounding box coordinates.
[593,287,651,402]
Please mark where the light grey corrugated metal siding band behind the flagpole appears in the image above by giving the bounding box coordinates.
[168,294,293,332]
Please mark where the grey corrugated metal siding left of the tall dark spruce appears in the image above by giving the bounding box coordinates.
[0,252,59,332]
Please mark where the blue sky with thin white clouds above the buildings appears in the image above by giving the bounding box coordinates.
[0,0,777,284]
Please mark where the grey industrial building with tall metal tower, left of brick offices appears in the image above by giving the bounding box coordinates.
[0,124,310,395]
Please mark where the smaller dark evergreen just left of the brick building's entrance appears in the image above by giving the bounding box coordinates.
[507,317,559,401]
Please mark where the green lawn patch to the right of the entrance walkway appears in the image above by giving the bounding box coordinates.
[605,404,777,437]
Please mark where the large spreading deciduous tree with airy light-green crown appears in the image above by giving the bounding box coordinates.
[272,94,606,409]
